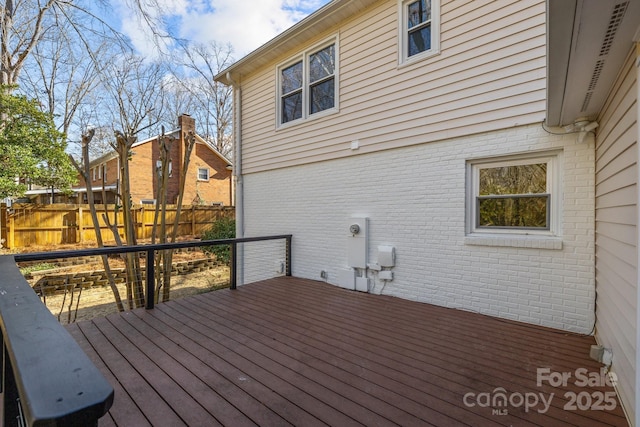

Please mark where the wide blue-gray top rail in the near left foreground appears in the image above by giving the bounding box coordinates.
[0,255,113,426]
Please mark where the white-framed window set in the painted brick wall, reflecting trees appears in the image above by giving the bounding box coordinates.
[467,153,562,236]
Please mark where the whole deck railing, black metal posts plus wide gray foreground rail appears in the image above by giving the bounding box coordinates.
[0,235,291,426]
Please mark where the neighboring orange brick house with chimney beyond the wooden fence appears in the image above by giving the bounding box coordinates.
[74,115,233,206]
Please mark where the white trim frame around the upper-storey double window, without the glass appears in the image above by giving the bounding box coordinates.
[275,34,340,130]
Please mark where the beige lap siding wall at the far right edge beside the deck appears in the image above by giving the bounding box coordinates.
[596,49,638,419]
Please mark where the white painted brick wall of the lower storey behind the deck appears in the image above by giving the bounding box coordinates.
[244,124,595,333]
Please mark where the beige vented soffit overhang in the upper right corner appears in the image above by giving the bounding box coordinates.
[547,0,640,126]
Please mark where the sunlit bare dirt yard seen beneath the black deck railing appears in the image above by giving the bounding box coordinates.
[41,267,229,324]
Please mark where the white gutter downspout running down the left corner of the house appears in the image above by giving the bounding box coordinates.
[226,72,244,285]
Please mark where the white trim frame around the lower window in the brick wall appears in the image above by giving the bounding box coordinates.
[466,151,562,237]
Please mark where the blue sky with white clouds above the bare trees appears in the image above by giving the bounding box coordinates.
[113,0,330,59]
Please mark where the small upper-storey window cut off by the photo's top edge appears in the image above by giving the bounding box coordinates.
[398,0,440,64]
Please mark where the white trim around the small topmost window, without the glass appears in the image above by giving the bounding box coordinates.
[398,0,440,66]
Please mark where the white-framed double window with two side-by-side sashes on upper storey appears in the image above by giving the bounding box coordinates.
[276,37,338,126]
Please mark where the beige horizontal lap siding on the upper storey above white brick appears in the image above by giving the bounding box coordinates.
[242,0,546,173]
